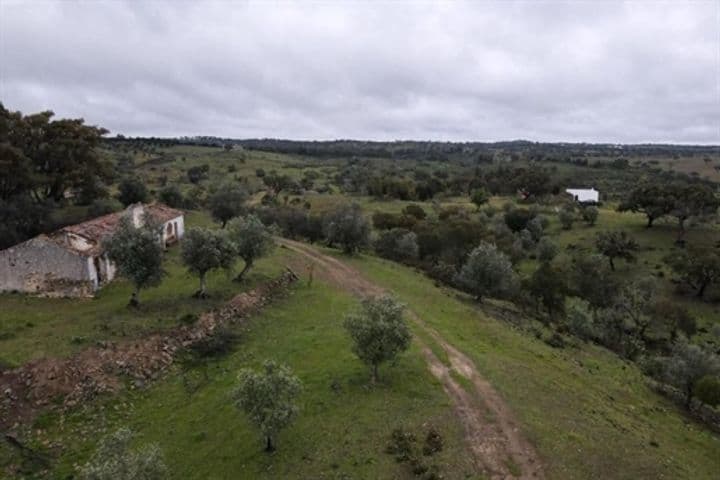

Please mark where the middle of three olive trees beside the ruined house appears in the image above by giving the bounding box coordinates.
[180,228,236,298]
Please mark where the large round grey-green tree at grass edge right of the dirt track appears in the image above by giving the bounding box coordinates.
[455,242,518,302]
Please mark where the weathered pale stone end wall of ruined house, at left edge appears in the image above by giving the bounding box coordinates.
[0,236,94,296]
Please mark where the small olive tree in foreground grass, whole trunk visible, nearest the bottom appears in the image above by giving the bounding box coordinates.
[233,360,302,452]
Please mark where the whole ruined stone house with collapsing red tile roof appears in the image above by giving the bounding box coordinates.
[0,203,185,297]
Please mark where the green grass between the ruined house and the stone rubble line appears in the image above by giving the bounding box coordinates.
[0,212,287,365]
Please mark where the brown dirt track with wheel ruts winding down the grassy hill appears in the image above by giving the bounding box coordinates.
[278,239,544,480]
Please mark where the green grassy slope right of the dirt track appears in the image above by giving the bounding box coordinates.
[343,256,720,479]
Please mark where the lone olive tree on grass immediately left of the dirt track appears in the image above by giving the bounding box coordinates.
[345,295,410,383]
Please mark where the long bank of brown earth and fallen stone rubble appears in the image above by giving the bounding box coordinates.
[0,269,298,430]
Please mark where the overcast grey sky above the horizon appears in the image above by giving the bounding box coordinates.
[0,0,720,144]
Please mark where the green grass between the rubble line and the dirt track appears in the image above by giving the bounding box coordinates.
[7,281,476,480]
